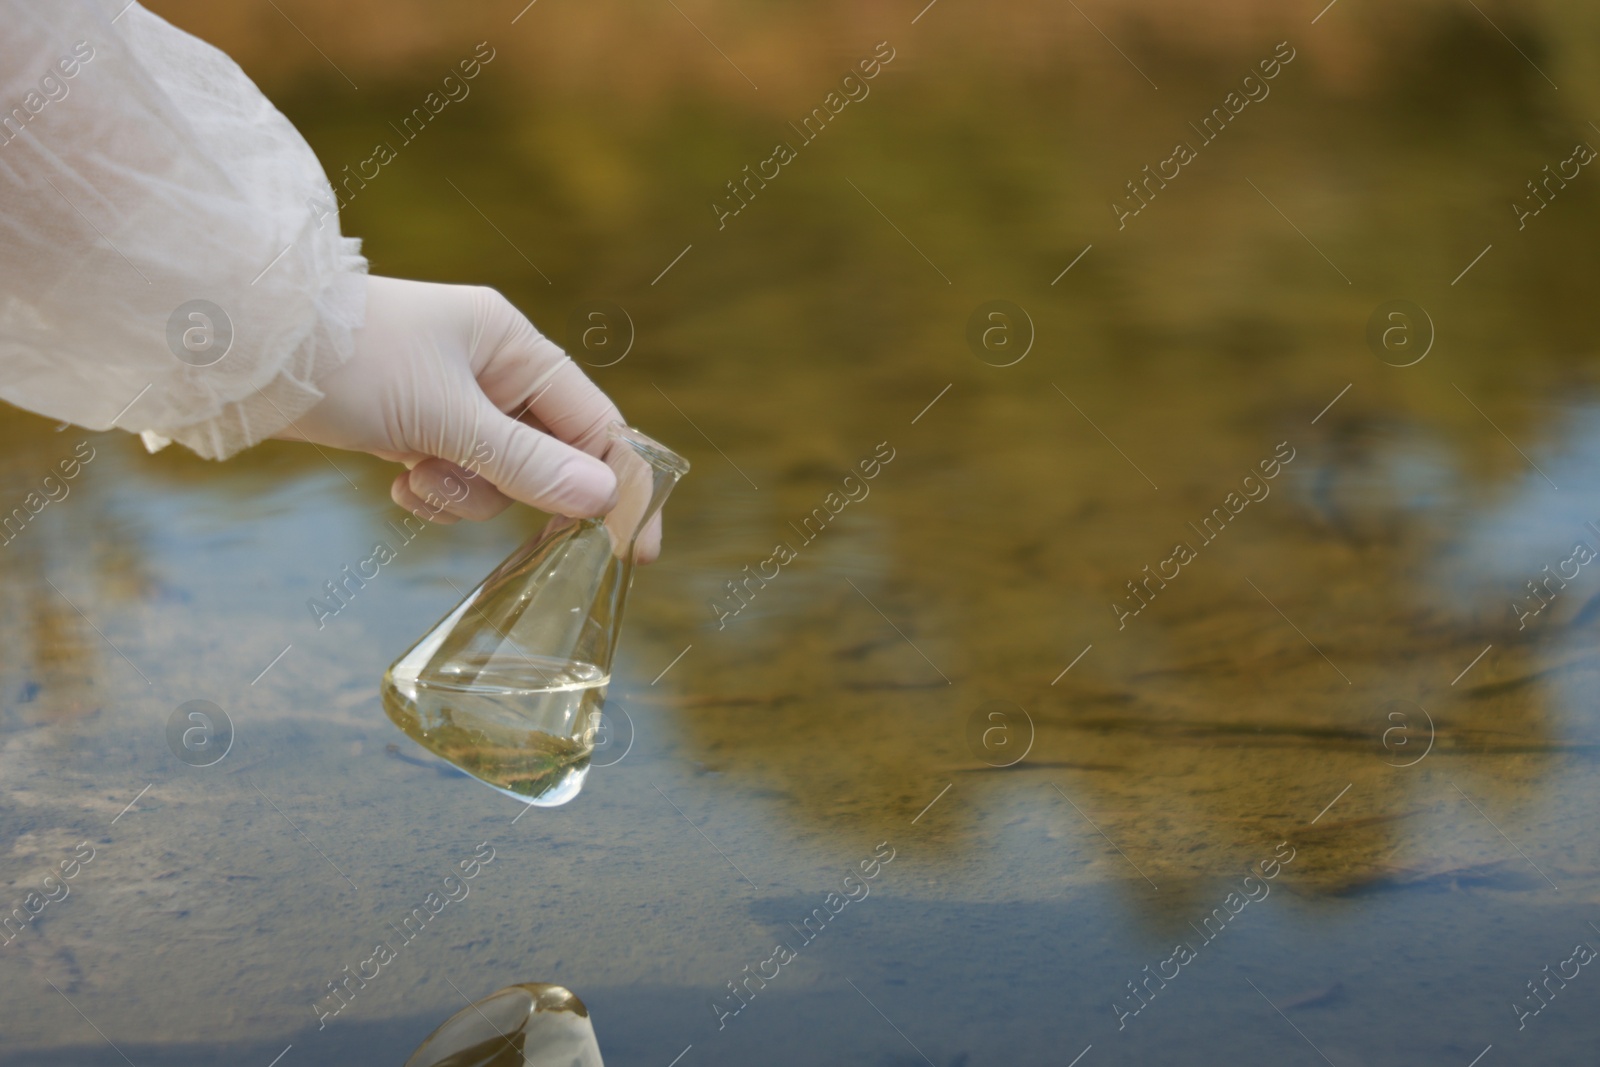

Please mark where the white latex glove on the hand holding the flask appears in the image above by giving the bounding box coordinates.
[278,277,661,561]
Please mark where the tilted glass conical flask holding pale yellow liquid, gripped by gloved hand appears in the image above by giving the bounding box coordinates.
[382,424,690,808]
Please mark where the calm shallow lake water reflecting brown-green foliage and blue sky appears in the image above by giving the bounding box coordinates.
[0,0,1600,1067]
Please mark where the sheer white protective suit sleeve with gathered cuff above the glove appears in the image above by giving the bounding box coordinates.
[0,0,366,459]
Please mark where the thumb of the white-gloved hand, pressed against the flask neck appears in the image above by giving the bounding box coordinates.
[472,397,616,518]
